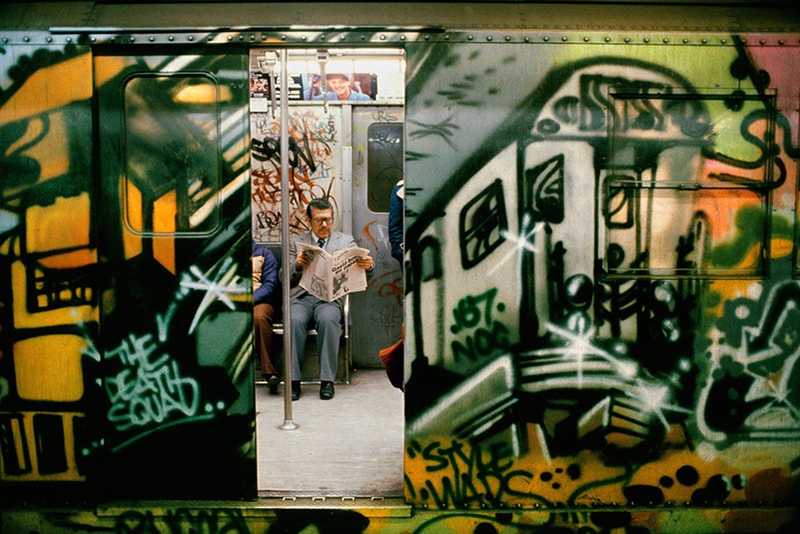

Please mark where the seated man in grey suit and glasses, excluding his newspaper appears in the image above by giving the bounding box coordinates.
[289,198,374,400]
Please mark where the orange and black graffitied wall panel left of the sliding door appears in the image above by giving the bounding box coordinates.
[0,46,101,498]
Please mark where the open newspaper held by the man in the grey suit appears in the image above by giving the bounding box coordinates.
[297,243,369,302]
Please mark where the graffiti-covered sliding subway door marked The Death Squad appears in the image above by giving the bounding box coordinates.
[95,48,256,499]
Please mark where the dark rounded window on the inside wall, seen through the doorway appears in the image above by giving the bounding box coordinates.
[367,122,403,213]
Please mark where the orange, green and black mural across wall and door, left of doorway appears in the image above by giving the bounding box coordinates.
[0,46,255,500]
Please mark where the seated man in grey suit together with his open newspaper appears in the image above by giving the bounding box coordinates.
[289,198,374,400]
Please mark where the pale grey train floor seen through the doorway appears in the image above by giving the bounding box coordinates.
[256,369,404,498]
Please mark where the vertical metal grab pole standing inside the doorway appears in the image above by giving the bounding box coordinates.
[280,48,297,430]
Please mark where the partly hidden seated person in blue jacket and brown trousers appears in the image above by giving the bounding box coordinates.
[252,240,281,395]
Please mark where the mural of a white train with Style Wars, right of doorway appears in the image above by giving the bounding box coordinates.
[406,36,800,526]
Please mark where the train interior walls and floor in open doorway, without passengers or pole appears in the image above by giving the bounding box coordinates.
[250,48,405,497]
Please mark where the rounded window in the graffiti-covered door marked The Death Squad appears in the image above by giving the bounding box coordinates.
[123,74,223,235]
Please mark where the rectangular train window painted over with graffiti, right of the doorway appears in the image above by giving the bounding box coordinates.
[598,86,775,278]
